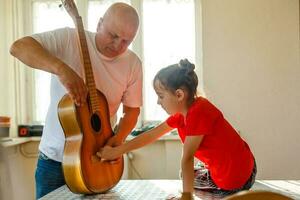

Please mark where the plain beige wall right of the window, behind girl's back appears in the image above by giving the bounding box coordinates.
[202,0,300,179]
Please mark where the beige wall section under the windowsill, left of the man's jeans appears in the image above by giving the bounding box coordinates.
[0,142,38,200]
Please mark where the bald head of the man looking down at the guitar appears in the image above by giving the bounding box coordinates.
[96,3,139,58]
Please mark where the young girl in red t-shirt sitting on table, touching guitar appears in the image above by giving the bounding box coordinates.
[97,59,256,199]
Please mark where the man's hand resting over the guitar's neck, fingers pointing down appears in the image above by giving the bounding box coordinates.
[57,66,87,106]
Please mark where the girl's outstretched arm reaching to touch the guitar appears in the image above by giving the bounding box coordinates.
[97,122,173,160]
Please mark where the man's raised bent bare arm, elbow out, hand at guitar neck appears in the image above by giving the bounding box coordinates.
[10,37,87,105]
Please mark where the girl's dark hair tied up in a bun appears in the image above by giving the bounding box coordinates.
[153,59,198,103]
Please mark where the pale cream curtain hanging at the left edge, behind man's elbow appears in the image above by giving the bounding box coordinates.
[0,0,32,137]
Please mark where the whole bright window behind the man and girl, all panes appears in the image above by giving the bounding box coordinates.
[32,0,196,125]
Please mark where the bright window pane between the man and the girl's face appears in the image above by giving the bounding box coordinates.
[143,0,195,121]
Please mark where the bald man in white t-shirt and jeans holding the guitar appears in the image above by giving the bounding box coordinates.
[10,3,142,199]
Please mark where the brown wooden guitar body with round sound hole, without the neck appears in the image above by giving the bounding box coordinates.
[58,88,124,194]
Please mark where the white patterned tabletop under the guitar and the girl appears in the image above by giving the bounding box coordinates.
[41,180,300,200]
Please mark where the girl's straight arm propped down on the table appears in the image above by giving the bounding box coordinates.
[181,136,203,193]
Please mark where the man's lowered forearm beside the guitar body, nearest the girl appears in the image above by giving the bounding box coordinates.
[106,106,140,146]
